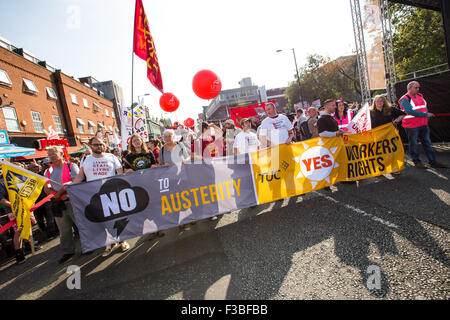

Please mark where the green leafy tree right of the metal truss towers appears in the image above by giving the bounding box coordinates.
[390,3,448,80]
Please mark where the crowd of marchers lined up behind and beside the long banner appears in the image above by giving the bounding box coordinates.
[0,81,446,263]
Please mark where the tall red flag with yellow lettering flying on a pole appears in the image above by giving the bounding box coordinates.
[133,0,164,93]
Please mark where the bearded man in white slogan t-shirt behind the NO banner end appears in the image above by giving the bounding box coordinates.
[73,137,130,257]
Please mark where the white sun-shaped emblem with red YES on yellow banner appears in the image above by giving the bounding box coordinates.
[294,139,339,189]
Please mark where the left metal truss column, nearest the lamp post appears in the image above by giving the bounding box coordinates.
[350,0,371,104]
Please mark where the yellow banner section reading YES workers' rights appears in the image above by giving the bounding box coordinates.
[251,124,404,204]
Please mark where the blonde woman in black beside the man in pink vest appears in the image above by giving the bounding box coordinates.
[370,95,406,129]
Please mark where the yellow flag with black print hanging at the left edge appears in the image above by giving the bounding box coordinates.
[2,162,47,239]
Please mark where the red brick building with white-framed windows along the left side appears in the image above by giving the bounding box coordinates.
[0,38,118,158]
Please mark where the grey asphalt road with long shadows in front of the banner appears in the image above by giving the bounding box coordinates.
[0,146,450,300]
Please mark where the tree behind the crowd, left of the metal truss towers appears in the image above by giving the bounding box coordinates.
[285,54,361,107]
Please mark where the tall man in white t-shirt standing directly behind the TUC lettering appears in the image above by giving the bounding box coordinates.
[259,102,294,148]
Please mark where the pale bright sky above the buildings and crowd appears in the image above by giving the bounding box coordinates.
[0,0,355,121]
